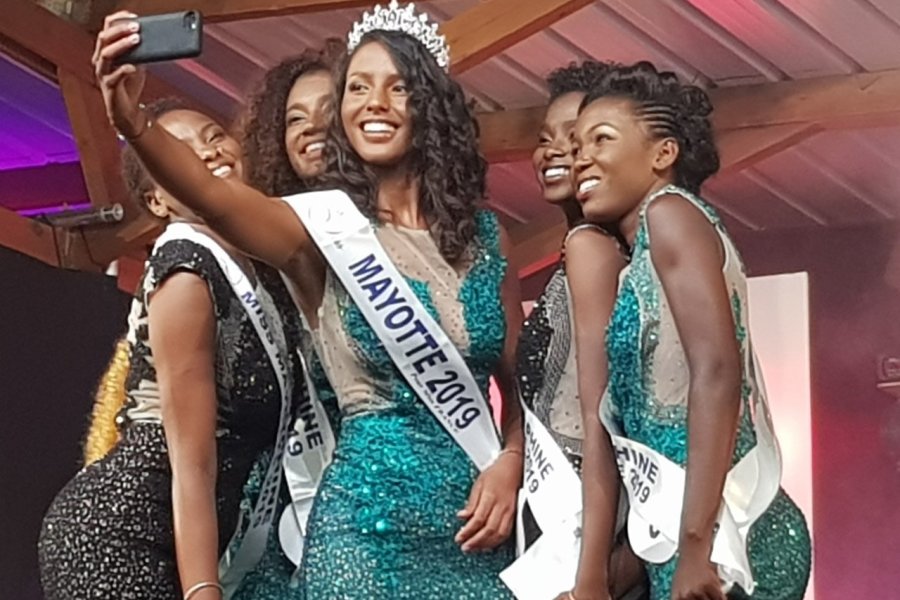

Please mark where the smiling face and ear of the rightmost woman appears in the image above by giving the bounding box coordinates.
[573,97,678,222]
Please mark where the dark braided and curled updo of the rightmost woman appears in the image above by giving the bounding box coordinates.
[581,61,719,193]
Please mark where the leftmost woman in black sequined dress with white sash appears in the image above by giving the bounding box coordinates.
[38,101,303,600]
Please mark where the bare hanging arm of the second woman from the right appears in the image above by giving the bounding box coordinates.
[566,229,625,600]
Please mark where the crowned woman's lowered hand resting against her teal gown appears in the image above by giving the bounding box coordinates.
[455,452,522,552]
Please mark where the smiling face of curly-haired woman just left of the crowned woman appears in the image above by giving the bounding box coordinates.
[284,71,333,179]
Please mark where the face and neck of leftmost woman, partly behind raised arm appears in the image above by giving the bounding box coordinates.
[148,109,243,221]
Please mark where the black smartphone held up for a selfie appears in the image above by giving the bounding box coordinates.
[116,10,203,64]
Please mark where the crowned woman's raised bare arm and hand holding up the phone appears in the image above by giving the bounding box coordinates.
[93,11,314,269]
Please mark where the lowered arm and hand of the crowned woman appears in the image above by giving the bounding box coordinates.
[456,220,525,552]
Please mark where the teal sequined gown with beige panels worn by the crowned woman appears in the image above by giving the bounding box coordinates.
[298,212,513,600]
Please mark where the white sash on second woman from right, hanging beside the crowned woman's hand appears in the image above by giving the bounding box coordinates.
[500,403,582,600]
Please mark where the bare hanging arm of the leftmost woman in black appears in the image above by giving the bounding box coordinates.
[149,273,220,600]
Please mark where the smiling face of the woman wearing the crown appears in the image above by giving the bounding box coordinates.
[341,41,412,167]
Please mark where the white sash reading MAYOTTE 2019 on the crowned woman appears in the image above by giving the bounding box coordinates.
[284,190,500,471]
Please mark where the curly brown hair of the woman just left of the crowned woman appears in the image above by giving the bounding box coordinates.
[241,38,344,196]
